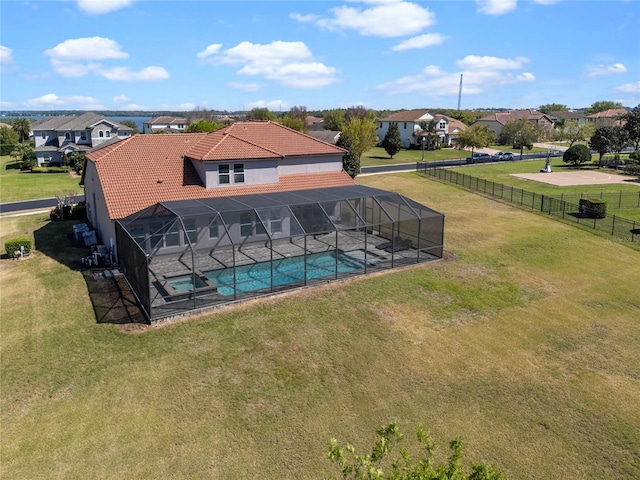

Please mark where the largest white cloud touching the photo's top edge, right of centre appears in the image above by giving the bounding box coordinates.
[300,1,435,37]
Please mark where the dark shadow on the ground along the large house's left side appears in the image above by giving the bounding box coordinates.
[33,220,147,325]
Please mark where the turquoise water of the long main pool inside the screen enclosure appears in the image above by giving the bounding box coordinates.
[203,251,365,295]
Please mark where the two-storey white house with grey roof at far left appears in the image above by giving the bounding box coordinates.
[31,112,131,165]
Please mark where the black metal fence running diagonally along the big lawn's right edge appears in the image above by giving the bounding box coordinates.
[417,162,640,242]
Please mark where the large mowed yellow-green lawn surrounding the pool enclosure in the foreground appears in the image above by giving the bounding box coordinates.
[0,173,640,479]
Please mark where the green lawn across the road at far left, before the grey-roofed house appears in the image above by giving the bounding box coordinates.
[0,155,84,203]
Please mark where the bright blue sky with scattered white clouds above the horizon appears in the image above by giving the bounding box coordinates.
[0,0,640,112]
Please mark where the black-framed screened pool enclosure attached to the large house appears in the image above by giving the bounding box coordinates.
[116,186,444,322]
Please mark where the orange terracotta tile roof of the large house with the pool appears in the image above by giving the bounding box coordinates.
[81,122,355,219]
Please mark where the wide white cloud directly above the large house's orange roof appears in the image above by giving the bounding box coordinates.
[201,41,338,88]
